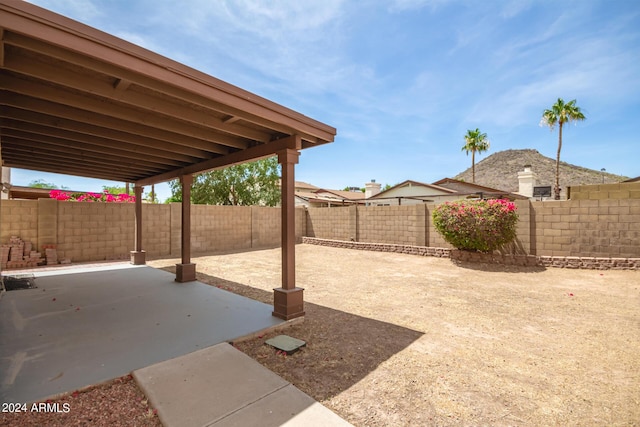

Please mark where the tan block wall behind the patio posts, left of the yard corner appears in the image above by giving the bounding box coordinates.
[0,199,306,262]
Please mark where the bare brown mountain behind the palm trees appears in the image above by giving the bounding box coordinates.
[454,149,628,193]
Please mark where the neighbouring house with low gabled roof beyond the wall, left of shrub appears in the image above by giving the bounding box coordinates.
[366,178,526,206]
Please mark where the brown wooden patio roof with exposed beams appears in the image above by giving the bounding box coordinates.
[0,0,336,185]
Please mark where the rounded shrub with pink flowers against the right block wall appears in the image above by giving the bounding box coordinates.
[433,199,518,252]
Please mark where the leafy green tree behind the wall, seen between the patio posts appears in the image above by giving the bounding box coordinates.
[167,157,280,206]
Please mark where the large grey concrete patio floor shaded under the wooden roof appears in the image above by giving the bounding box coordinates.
[0,263,283,402]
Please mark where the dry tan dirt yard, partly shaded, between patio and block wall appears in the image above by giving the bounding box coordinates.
[149,245,640,426]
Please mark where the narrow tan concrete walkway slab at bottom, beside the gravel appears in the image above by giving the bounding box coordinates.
[133,343,351,427]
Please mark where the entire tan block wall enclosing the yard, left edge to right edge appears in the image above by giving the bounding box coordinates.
[0,183,640,262]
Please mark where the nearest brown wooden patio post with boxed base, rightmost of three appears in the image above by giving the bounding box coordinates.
[273,149,304,320]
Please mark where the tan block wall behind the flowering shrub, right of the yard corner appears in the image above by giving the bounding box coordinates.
[307,196,640,258]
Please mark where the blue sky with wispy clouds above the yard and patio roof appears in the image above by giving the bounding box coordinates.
[12,0,640,200]
